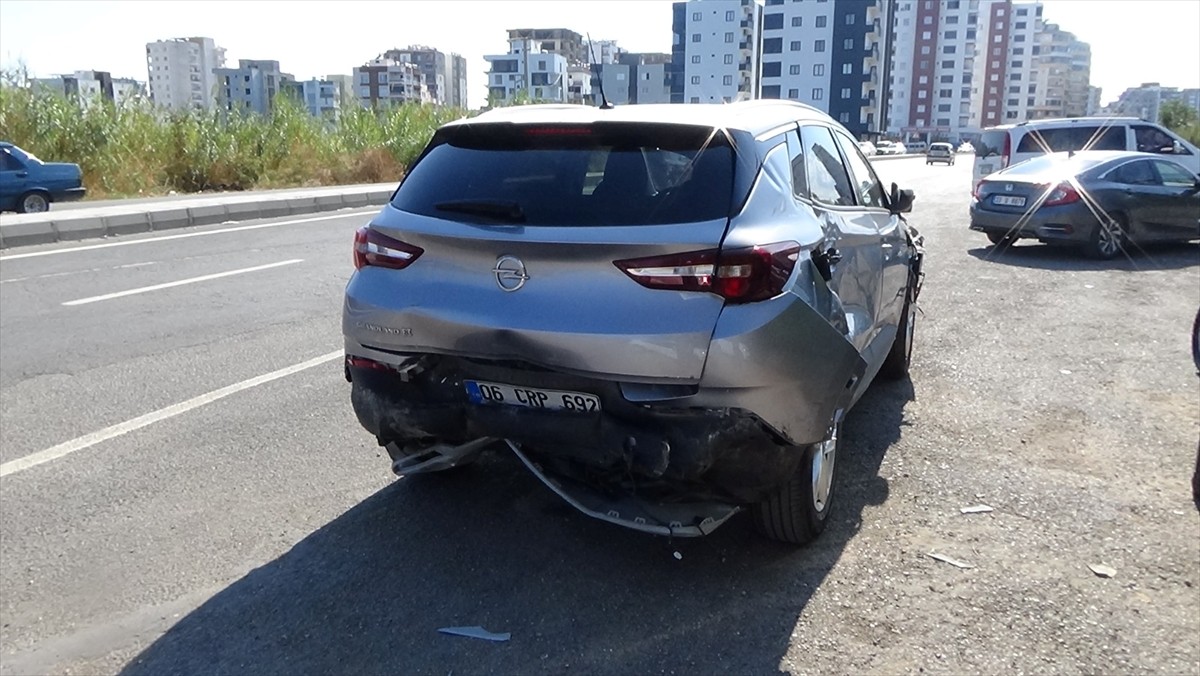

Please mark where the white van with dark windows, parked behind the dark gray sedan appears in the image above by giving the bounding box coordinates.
[971,118,1200,187]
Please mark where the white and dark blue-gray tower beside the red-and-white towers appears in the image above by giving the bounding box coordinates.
[762,0,889,136]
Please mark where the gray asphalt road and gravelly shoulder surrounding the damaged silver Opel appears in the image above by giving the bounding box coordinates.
[0,158,1200,675]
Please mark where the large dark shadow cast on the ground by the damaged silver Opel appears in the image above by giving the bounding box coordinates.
[122,379,914,676]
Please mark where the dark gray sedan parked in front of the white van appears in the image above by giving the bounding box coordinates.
[971,151,1200,259]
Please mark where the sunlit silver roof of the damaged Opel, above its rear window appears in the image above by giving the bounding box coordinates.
[446,100,833,136]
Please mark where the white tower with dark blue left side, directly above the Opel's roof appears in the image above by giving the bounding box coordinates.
[670,0,763,103]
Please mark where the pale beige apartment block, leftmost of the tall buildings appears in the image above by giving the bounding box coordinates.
[146,37,224,110]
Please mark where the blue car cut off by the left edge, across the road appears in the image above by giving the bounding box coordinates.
[0,140,86,214]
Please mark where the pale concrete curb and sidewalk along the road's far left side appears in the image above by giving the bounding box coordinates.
[0,183,396,249]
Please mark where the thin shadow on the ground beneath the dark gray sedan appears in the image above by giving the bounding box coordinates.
[967,237,1200,273]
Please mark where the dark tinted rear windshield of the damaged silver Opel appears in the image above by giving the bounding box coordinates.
[392,122,733,226]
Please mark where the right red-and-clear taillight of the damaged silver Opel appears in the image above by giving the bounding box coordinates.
[613,241,800,303]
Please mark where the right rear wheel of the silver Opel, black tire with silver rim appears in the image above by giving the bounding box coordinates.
[752,423,841,545]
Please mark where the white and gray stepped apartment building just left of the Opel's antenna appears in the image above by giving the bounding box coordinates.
[484,36,566,104]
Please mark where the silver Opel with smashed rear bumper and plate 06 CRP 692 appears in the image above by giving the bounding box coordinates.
[343,101,923,543]
